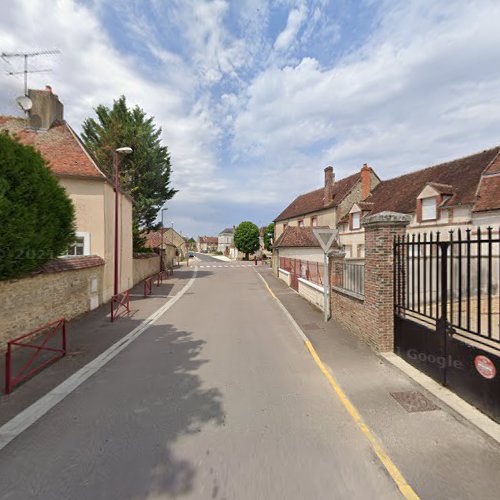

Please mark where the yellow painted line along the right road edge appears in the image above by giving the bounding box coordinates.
[256,270,419,500]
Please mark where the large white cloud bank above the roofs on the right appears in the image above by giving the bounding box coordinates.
[234,1,500,195]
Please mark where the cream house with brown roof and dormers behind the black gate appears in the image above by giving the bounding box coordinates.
[338,146,500,250]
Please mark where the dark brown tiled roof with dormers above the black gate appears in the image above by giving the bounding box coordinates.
[365,146,500,214]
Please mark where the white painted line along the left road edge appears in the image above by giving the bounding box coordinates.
[0,266,198,450]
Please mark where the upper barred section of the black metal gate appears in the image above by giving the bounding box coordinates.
[394,227,500,347]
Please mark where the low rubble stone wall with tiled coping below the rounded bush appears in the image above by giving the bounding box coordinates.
[0,256,104,350]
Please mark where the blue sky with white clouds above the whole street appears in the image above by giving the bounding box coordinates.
[0,0,500,237]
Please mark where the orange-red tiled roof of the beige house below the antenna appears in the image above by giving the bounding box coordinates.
[0,116,107,180]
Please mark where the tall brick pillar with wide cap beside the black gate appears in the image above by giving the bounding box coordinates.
[362,212,411,352]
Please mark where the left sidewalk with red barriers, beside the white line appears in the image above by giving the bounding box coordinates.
[0,266,199,426]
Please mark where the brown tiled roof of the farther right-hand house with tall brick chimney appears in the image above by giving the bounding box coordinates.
[274,172,361,222]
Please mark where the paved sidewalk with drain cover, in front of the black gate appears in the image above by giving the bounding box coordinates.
[258,269,500,499]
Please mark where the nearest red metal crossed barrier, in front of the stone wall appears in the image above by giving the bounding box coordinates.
[5,318,66,394]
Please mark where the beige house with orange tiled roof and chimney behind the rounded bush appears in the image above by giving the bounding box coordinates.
[0,87,133,302]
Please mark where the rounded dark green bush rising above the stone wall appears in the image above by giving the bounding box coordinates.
[0,133,75,278]
